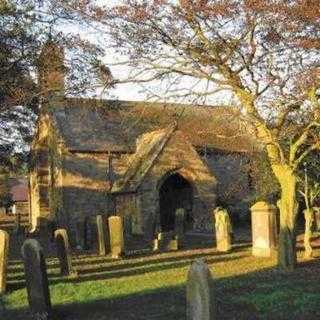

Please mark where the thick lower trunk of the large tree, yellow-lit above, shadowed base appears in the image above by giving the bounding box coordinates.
[272,165,298,271]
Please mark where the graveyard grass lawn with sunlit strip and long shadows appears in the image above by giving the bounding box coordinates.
[0,236,320,320]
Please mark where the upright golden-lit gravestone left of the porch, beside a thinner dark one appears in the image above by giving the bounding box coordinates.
[108,216,124,259]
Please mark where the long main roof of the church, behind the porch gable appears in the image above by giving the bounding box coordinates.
[51,98,255,152]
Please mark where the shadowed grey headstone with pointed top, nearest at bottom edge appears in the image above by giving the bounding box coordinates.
[186,259,216,320]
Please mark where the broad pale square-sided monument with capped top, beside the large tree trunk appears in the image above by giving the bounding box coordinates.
[251,201,277,257]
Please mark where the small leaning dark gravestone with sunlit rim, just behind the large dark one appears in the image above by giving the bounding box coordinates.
[54,229,76,276]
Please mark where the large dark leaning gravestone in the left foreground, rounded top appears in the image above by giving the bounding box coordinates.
[21,239,52,320]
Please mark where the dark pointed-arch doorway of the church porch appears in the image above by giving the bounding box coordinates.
[159,173,193,231]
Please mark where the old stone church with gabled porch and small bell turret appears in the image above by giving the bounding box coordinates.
[30,41,254,244]
